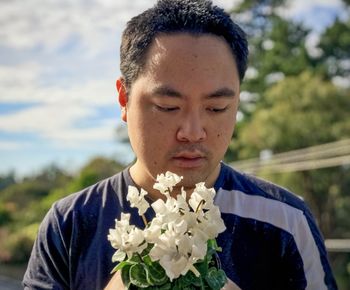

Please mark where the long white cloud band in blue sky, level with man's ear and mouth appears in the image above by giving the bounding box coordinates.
[0,104,119,147]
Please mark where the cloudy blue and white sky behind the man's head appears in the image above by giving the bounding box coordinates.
[0,0,341,176]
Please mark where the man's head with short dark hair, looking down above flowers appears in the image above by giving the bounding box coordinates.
[117,0,247,197]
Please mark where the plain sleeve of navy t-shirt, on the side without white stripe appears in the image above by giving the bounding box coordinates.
[23,206,70,290]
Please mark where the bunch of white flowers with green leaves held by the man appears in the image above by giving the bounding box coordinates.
[108,172,227,290]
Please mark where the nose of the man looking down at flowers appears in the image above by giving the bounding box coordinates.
[177,111,207,142]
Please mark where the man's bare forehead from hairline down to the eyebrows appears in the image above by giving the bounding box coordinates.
[133,33,239,95]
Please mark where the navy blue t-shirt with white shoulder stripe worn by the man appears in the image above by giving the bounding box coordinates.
[23,163,337,290]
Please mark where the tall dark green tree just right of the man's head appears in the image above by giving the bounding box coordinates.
[232,5,316,122]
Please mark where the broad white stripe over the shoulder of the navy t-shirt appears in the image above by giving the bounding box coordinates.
[215,189,327,290]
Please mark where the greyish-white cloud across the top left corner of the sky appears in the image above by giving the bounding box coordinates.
[0,0,154,49]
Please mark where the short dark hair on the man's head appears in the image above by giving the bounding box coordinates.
[120,0,248,88]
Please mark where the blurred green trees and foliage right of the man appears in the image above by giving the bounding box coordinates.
[225,0,350,289]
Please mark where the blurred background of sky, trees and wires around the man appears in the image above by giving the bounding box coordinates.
[0,0,350,290]
